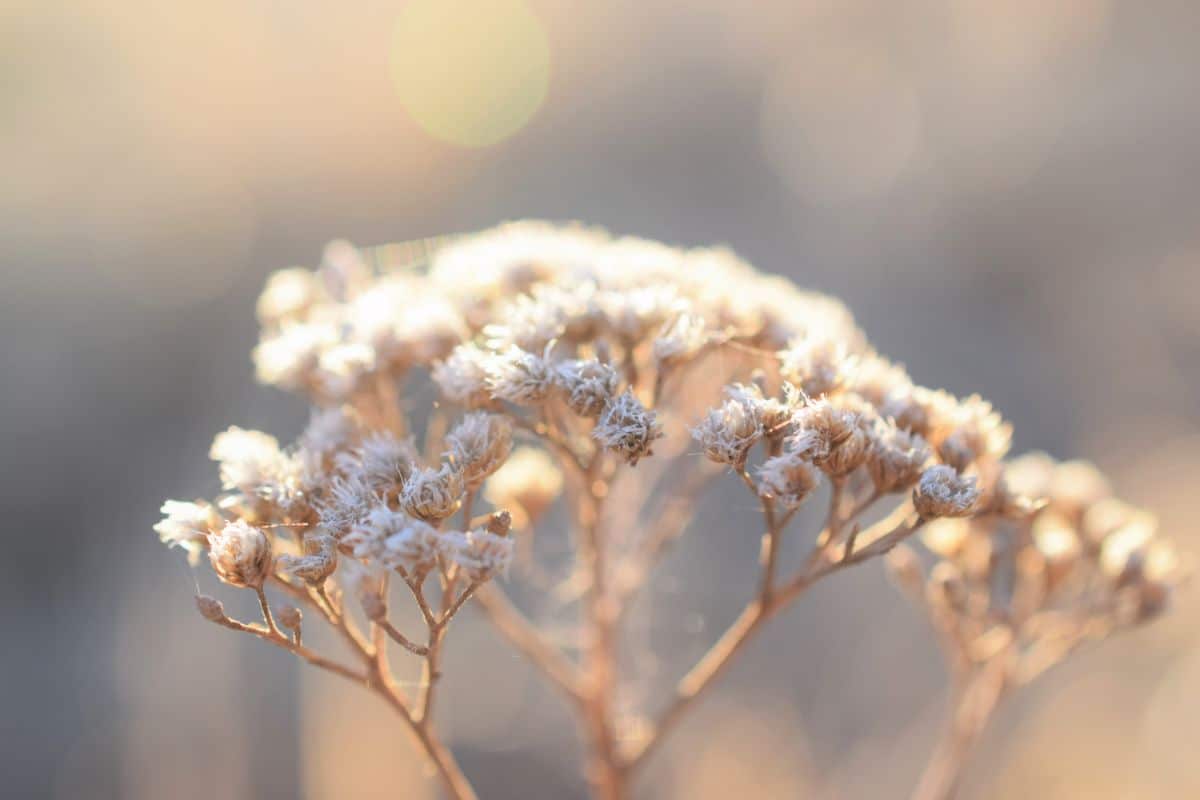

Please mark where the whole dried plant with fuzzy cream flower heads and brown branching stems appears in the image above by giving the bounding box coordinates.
[156,223,1178,800]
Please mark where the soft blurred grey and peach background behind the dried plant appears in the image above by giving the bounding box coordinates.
[0,0,1200,800]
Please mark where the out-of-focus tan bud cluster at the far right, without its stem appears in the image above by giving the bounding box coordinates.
[889,453,1182,686]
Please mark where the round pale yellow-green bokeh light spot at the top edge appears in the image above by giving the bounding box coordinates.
[391,0,550,148]
